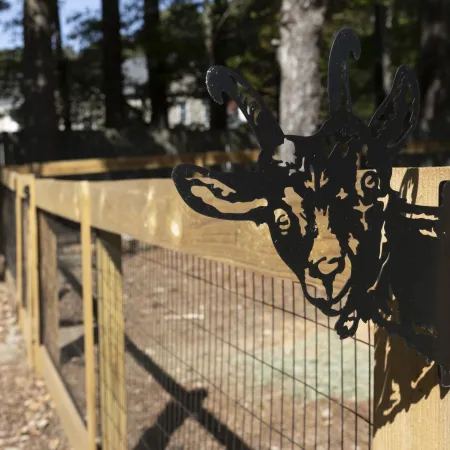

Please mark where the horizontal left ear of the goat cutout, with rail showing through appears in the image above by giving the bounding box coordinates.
[172,164,267,224]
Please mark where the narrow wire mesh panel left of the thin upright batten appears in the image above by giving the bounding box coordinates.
[38,210,101,438]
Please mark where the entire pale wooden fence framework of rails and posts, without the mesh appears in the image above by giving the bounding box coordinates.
[0,153,450,450]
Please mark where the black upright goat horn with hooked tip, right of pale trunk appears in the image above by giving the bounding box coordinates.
[328,28,361,114]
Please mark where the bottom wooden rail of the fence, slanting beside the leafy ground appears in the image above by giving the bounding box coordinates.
[39,346,89,450]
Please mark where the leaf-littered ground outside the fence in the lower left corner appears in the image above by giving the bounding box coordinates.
[0,283,71,450]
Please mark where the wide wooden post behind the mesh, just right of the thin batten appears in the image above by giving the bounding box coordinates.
[97,231,127,450]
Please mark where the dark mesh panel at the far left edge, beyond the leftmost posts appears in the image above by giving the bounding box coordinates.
[1,186,17,288]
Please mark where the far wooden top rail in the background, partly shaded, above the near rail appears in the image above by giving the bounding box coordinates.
[5,150,259,177]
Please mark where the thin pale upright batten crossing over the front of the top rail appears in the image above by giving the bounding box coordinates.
[79,181,97,450]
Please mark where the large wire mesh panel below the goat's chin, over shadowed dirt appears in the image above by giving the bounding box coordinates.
[119,243,373,450]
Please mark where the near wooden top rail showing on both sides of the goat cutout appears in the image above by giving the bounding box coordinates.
[36,167,450,279]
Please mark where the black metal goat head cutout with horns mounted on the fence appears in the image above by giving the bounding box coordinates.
[172,29,450,384]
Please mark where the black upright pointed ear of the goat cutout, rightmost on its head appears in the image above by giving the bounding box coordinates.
[369,66,420,156]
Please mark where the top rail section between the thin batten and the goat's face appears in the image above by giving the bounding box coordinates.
[90,180,304,284]
